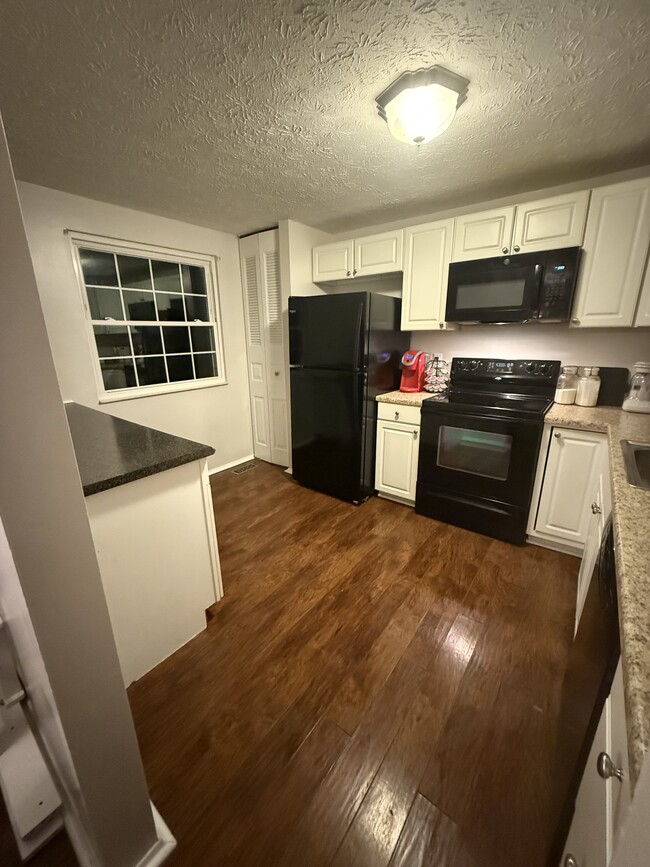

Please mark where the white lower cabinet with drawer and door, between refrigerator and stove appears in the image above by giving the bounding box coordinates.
[375,403,420,505]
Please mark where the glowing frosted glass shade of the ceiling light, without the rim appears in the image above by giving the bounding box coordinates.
[385,84,458,144]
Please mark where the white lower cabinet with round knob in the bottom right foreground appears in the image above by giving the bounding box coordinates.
[560,662,632,867]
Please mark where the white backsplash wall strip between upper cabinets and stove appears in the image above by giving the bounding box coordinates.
[412,325,650,369]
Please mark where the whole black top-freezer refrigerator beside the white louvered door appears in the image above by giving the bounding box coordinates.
[289,292,410,504]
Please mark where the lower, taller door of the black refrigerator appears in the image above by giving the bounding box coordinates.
[291,367,369,502]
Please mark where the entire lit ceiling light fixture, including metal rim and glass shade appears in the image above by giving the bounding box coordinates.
[376,66,469,145]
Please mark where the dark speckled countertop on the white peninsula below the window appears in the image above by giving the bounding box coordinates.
[65,403,214,497]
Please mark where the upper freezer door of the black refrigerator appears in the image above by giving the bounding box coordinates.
[289,292,368,370]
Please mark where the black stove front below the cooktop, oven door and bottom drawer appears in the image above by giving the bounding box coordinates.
[415,408,543,544]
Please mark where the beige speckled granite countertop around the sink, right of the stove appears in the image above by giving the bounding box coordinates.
[546,404,650,784]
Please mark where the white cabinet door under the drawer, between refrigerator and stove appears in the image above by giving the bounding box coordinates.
[375,421,420,502]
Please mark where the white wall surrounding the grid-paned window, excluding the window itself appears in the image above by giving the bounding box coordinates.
[18,183,253,469]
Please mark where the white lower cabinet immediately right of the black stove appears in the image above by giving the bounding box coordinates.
[528,427,607,556]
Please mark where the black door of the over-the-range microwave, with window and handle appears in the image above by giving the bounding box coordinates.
[445,254,544,322]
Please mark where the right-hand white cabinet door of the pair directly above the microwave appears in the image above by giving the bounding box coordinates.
[512,190,589,253]
